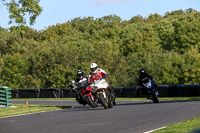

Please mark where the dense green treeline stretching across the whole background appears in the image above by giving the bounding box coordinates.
[0,9,200,89]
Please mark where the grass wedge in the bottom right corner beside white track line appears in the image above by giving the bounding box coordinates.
[152,117,200,133]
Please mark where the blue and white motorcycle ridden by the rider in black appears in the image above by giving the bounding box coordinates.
[142,78,159,103]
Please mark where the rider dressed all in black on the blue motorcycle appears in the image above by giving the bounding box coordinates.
[138,68,157,99]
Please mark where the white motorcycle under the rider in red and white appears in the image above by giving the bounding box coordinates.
[90,76,114,109]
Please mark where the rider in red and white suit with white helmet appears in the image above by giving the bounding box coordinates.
[89,63,116,105]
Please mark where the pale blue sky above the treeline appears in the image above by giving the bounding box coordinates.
[0,0,200,30]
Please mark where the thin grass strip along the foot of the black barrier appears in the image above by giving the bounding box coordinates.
[12,97,200,101]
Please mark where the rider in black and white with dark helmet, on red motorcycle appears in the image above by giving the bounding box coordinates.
[72,69,88,105]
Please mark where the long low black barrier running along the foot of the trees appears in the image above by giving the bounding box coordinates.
[8,84,200,98]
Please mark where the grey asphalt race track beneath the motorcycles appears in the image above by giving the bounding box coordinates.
[0,101,200,133]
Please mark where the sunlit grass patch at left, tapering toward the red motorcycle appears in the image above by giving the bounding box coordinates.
[0,104,71,117]
